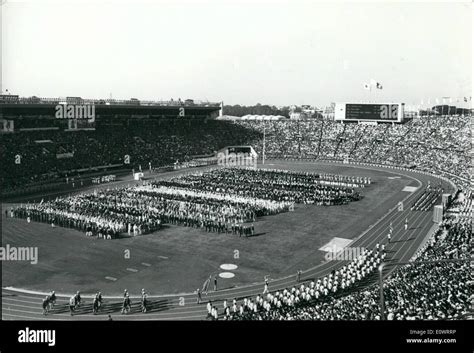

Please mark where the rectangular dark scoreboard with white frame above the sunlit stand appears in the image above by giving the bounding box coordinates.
[334,103,405,123]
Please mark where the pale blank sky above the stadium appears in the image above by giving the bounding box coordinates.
[2,0,472,106]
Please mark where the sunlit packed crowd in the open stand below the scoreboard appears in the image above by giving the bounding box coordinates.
[238,116,471,187]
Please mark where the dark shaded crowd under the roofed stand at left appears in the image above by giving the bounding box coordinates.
[0,117,258,193]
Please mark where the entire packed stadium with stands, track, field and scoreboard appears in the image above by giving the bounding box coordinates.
[0,95,474,321]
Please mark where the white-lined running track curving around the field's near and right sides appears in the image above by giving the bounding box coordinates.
[2,162,453,321]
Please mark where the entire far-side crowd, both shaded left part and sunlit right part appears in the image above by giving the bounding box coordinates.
[0,116,471,192]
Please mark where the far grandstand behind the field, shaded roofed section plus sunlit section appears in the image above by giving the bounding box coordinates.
[0,95,471,196]
